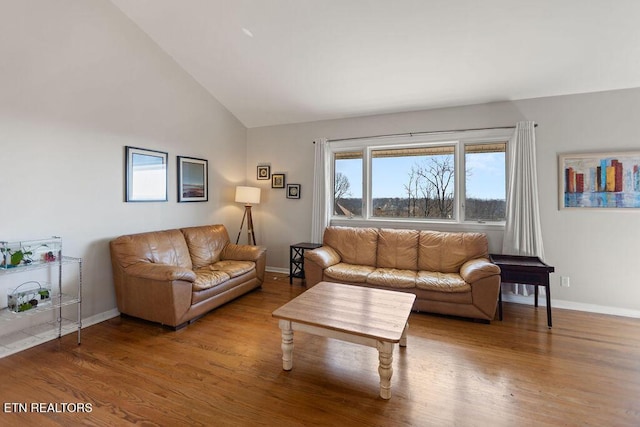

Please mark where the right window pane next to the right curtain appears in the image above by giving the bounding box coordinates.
[464,143,507,221]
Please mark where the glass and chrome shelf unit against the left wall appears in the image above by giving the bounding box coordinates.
[0,237,82,358]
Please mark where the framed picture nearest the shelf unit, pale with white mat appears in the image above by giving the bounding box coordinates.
[124,146,169,202]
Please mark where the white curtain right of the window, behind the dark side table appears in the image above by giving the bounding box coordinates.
[502,121,544,296]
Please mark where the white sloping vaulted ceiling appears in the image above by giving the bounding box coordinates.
[111,0,640,128]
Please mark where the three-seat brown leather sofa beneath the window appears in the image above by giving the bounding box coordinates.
[304,226,500,321]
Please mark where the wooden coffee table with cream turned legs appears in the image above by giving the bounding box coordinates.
[273,282,416,399]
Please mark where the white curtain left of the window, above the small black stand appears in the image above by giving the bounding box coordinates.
[311,138,333,243]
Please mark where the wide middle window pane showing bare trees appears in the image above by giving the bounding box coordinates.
[371,145,455,219]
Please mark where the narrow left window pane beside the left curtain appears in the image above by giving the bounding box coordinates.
[333,151,362,217]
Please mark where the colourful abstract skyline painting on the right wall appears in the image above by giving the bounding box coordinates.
[558,151,640,209]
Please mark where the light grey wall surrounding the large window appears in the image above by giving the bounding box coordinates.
[247,89,640,315]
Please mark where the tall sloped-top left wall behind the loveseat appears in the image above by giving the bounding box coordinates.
[0,0,246,317]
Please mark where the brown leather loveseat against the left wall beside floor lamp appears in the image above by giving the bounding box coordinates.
[110,225,266,329]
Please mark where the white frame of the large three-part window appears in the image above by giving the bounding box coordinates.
[326,128,514,229]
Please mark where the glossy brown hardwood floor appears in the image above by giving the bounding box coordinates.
[0,273,640,427]
